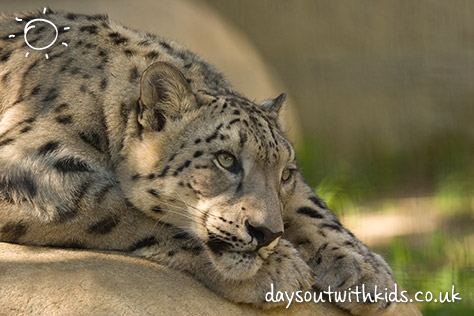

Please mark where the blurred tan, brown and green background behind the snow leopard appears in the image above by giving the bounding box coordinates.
[0,0,474,315]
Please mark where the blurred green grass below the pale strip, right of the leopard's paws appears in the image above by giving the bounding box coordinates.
[384,230,474,315]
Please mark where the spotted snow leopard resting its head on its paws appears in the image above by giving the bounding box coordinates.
[0,10,394,314]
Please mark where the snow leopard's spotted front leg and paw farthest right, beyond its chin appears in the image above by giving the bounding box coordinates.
[283,173,395,315]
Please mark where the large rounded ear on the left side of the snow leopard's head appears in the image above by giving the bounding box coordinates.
[138,62,197,131]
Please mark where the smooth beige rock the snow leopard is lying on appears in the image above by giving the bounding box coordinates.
[0,243,421,316]
